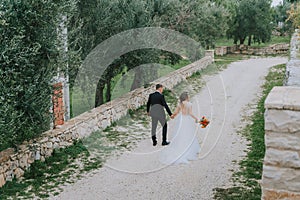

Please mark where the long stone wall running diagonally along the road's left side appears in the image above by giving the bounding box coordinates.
[0,51,214,187]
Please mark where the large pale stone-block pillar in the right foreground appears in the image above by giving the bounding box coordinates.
[262,86,300,200]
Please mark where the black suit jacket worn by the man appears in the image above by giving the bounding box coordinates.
[147,92,172,118]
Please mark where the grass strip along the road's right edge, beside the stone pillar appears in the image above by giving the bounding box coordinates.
[215,65,285,200]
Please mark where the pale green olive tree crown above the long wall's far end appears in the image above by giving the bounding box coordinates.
[167,0,231,49]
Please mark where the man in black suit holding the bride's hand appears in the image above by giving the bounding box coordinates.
[147,84,174,146]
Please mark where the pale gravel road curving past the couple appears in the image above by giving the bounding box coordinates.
[51,57,287,200]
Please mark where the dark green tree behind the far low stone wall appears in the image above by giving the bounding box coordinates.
[228,0,273,46]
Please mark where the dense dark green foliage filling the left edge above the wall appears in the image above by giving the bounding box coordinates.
[0,0,58,149]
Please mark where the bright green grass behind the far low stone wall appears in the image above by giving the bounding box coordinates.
[216,35,291,47]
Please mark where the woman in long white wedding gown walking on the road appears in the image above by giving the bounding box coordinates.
[160,92,200,164]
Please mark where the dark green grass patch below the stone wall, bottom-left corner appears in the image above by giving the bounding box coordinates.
[0,141,102,199]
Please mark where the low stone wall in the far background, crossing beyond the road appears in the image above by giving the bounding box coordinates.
[215,43,290,56]
